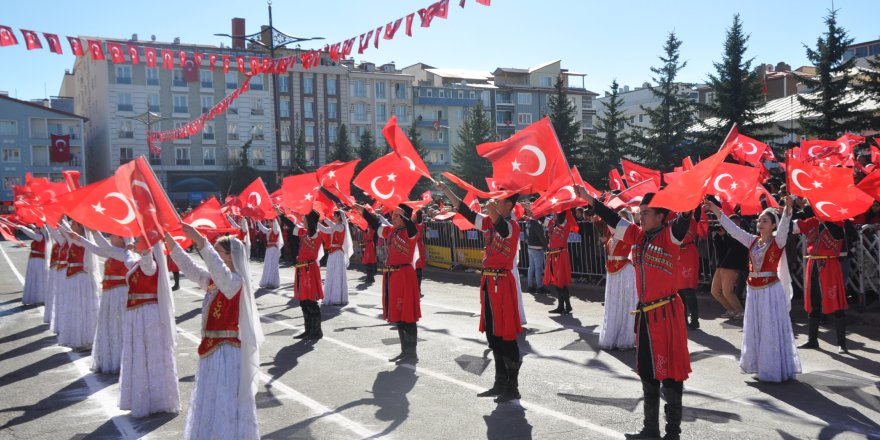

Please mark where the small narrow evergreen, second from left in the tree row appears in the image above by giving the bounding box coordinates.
[579,80,629,184]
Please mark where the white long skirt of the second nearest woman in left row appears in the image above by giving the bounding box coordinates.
[119,304,180,417]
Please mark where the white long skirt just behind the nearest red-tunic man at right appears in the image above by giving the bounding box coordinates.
[599,264,639,349]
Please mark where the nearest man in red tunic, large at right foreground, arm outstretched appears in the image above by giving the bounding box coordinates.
[577,186,691,440]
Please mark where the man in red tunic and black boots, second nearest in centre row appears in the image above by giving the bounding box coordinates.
[437,182,523,403]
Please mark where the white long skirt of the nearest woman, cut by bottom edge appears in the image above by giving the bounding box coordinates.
[185,344,260,440]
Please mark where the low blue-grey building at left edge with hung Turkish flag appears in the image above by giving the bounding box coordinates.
[0,94,91,212]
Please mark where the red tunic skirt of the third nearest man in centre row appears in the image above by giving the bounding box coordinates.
[382,264,422,323]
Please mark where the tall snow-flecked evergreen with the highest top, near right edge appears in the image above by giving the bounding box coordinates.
[798,10,865,139]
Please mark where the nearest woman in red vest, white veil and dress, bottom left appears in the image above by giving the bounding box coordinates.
[165,224,263,440]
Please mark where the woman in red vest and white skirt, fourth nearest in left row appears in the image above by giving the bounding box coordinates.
[55,222,99,349]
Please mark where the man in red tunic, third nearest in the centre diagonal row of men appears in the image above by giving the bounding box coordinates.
[355,205,422,364]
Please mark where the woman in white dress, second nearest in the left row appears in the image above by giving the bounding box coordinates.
[119,242,180,417]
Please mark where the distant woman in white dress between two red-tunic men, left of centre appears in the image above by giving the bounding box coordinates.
[318,211,353,306]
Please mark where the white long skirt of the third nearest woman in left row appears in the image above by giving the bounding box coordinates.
[92,285,128,374]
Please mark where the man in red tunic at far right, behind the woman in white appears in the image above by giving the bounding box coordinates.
[792,211,849,353]
